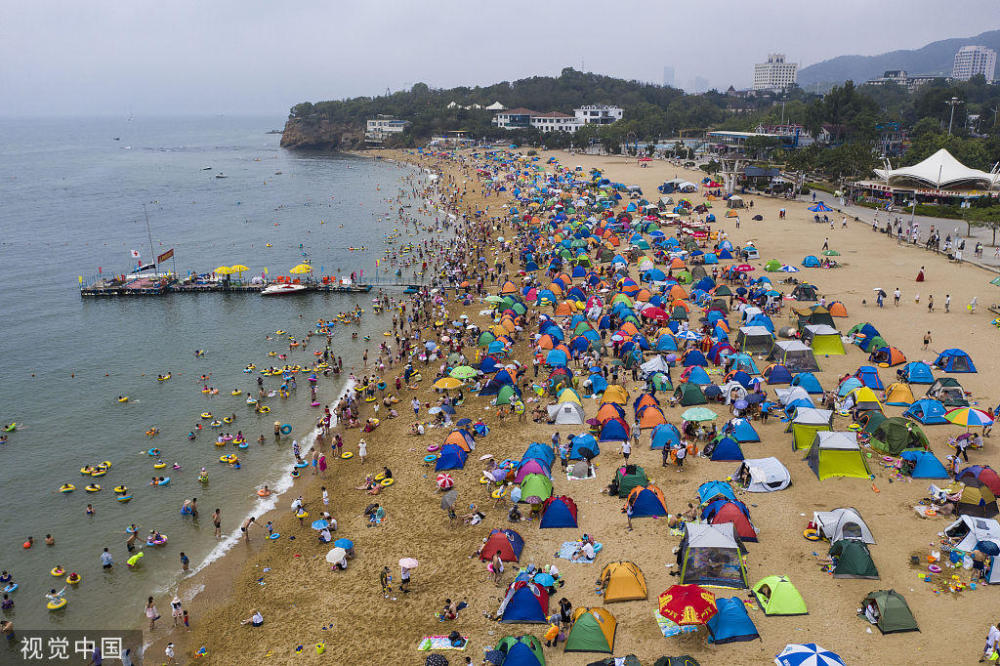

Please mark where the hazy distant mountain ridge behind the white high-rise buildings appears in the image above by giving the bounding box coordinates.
[798,30,1000,89]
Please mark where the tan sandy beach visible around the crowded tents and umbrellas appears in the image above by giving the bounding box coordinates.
[156,147,1000,666]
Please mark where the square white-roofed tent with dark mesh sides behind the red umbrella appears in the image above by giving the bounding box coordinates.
[678,523,748,589]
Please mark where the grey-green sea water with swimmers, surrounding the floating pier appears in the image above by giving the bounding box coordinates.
[0,117,430,629]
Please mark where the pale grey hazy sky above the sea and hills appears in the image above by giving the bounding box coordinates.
[0,0,1000,117]
